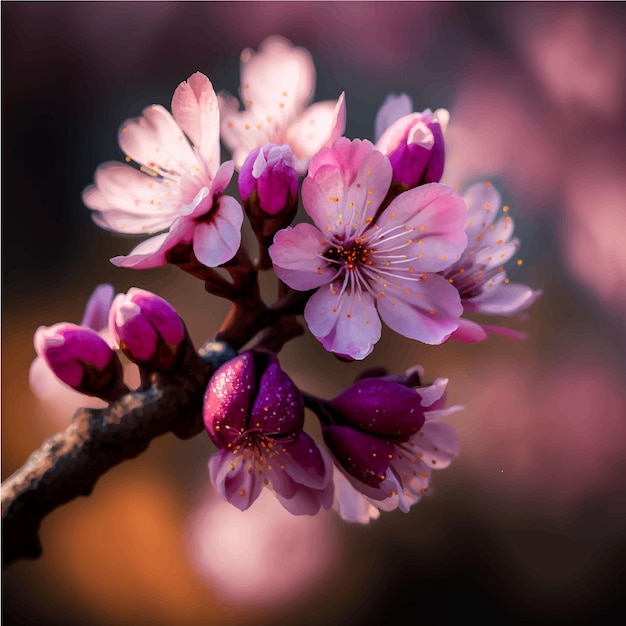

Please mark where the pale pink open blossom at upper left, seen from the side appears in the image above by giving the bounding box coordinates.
[83,72,243,269]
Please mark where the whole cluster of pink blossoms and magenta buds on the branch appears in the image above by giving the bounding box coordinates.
[35,37,540,523]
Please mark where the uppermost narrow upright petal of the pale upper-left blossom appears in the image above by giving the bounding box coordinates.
[172,72,220,172]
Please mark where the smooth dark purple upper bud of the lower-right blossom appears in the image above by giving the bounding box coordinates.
[328,378,424,437]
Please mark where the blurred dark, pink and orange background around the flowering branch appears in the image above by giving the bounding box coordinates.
[2,2,626,626]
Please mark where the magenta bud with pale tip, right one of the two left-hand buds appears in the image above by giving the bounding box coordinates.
[109,287,187,372]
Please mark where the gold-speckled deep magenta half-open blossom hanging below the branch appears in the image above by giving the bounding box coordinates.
[204,352,333,515]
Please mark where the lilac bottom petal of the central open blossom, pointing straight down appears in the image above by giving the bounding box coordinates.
[304,282,380,360]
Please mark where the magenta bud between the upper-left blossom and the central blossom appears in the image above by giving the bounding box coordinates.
[239,143,298,219]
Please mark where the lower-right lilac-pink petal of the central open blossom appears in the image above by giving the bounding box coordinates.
[377,274,463,345]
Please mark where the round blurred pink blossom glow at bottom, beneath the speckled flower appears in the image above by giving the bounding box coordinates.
[187,490,339,607]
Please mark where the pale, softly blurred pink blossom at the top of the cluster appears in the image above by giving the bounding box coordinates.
[218,36,346,174]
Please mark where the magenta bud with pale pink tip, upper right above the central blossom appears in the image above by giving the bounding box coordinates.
[376,109,450,189]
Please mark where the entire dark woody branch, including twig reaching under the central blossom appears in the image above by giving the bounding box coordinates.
[2,294,302,567]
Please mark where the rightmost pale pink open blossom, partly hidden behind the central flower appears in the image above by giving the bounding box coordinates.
[444,182,541,343]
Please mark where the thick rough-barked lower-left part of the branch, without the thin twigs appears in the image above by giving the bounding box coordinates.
[2,347,214,567]
